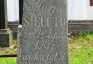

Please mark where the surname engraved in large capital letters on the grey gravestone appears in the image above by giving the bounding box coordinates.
[23,17,66,27]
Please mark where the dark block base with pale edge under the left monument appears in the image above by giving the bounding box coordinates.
[0,28,13,47]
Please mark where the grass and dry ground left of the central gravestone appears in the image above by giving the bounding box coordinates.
[0,39,17,64]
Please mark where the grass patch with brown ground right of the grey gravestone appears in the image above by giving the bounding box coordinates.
[69,33,93,64]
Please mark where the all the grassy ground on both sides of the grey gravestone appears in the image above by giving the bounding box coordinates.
[0,32,93,64]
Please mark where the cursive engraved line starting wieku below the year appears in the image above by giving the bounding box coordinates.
[22,52,65,61]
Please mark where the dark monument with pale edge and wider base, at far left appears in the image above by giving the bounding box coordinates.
[0,0,12,47]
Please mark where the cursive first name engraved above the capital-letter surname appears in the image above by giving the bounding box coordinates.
[24,0,64,16]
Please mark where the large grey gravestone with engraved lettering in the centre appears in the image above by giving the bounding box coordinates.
[18,0,68,64]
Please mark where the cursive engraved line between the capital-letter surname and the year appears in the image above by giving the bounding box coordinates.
[23,32,65,39]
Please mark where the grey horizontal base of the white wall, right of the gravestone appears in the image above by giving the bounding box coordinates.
[68,20,93,32]
